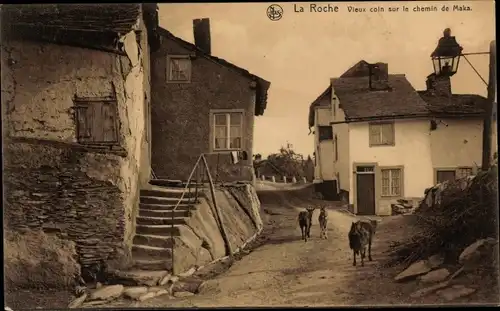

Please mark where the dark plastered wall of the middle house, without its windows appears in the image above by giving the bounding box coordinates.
[151,37,255,181]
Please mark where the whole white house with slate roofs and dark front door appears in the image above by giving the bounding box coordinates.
[309,61,496,215]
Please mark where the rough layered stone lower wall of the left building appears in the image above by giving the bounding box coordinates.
[4,140,127,266]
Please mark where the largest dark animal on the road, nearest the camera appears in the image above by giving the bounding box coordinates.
[349,220,377,266]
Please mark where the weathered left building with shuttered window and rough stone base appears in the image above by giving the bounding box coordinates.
[1,4,158,272]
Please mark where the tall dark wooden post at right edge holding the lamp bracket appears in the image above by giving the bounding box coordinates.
[481,40,496,171]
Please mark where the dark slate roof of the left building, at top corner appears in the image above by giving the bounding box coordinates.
[1,3,157,50]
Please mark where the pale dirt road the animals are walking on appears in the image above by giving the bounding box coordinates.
[114,184,414,307]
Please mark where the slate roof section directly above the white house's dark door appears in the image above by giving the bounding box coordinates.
[331,74,428,121]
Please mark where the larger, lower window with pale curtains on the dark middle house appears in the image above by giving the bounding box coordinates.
[212,112,243,151]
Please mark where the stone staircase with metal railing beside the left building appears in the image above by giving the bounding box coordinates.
[132,179,205,271]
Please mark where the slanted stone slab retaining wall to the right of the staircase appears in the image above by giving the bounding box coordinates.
[170,184,263,273]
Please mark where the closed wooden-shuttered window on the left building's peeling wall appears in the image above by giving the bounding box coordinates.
[75,98,118,145]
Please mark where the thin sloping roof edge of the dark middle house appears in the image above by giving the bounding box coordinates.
[157,28,271,116]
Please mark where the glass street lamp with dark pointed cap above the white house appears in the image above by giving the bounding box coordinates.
[431,28,463,77]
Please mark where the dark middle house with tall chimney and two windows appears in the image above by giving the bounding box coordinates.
[152,19,270,181]
